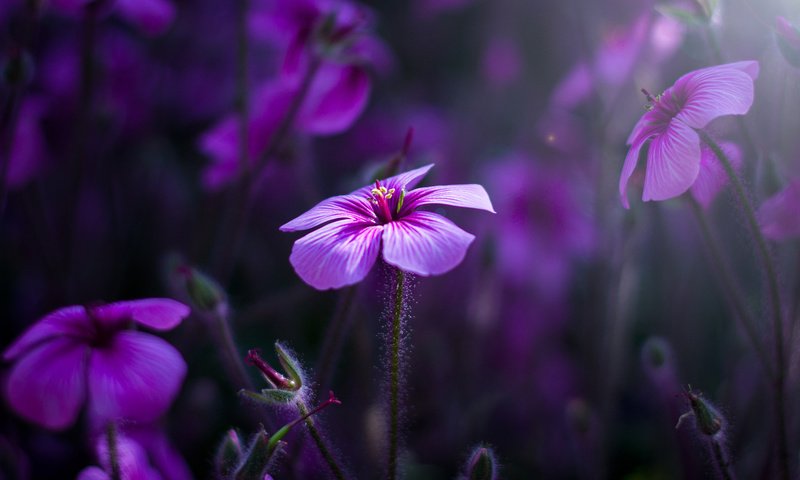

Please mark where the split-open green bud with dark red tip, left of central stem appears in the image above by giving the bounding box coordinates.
[241,342,305,405]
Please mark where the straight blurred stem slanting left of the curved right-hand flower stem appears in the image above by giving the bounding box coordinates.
[686,195,775,379]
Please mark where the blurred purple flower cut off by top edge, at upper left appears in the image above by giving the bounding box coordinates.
[50,0,175,36]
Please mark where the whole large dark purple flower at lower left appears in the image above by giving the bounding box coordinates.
[3,298,190,429]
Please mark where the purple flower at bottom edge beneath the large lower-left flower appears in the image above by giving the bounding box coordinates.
[78,435,162,480]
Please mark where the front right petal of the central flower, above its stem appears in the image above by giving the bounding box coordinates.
[383,211,475,276]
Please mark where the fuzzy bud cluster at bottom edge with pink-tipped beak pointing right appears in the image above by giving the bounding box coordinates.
[214,392,342,480]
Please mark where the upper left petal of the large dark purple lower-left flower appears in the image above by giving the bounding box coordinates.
[3,305,92,360]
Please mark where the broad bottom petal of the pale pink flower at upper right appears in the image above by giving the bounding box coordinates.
[642,119,700,201]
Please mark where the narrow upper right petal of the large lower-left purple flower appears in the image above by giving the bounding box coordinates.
[91,298,192,330]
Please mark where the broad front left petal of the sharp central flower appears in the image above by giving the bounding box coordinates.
[289,219,384,290]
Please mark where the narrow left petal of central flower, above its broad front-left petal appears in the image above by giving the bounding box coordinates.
[280,195,376,232]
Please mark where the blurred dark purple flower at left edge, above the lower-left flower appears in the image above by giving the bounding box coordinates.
[6,98,47,189]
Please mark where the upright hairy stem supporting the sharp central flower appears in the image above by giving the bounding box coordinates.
[387,268,405,480]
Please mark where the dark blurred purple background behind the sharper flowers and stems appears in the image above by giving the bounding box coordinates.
[0,0,800,479]
